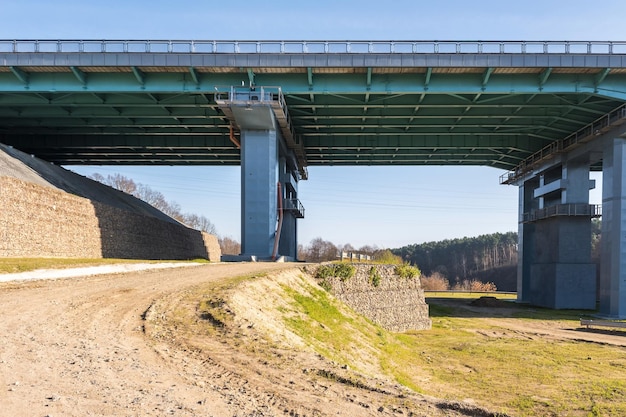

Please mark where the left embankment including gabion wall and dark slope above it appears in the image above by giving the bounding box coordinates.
[0,144,221,260]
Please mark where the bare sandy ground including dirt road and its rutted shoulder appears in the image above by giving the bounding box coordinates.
[0,263,490,417]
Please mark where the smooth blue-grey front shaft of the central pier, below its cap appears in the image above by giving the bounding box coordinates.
[241,130,279,258]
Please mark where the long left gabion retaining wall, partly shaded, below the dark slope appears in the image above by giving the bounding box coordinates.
[0,177,221,261]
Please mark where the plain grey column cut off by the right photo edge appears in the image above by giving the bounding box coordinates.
[600,139,626,318]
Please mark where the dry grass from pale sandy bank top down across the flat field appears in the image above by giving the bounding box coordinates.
[155,270,626,417]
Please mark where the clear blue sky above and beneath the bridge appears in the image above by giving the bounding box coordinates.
[0,0,626,247]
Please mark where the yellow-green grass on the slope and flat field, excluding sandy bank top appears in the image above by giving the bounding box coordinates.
[284,282,626,417]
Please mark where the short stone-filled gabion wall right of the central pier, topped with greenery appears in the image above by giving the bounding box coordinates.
[311,264,432,332]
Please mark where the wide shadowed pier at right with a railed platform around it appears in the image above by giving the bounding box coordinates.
[518,161,596,309]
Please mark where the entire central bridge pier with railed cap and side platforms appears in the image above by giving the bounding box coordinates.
[215,85,307,260]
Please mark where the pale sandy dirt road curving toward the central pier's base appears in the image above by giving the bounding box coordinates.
[0,264,294,417]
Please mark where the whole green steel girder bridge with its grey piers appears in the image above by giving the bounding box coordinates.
[0,40,626,317]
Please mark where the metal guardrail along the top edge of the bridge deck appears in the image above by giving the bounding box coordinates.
[0,39,626,55]
